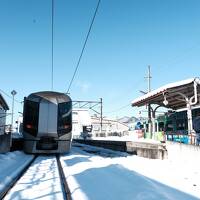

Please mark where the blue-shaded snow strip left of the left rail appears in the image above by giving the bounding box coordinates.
[0,151,33,195]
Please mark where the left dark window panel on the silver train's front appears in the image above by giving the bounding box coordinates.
[23,100,39,136]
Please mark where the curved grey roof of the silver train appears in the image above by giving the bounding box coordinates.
[27,91,71,103]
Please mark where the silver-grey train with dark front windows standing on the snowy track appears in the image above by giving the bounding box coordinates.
[23,91,72,154]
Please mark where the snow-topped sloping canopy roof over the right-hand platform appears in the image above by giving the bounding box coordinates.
[131,78,200,110]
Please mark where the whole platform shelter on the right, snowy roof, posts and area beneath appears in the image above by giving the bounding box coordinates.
[132,78,200,144]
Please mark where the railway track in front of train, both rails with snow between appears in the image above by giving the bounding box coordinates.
[0,155,71,200]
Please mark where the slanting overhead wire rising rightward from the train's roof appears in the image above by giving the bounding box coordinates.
[67,0,101,93]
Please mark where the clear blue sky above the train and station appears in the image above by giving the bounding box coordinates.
[0,0,200,122]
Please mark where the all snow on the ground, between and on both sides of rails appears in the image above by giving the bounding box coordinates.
[0,141,200,200]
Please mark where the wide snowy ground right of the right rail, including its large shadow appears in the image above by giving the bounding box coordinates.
[61,145,200,200]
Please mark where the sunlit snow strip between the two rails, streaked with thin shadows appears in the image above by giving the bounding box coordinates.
[5,156,64,200]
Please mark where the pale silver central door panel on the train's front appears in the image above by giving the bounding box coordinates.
[38,100,57,137]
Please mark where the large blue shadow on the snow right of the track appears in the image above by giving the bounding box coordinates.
[71,164,199,200]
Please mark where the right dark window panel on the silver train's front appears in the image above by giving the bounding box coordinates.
[58,101,72,136]
